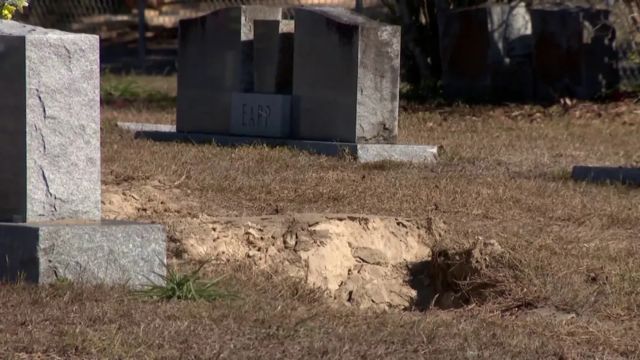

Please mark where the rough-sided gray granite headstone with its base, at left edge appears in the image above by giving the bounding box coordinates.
[0,21,166,286]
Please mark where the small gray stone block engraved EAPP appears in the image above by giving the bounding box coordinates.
[231,93,291,138]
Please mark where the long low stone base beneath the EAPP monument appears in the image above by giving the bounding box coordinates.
[118,122,438,164]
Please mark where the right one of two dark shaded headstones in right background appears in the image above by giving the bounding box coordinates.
[531,7,620,101]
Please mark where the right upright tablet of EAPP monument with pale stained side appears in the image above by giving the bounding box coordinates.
[292,7,400,143]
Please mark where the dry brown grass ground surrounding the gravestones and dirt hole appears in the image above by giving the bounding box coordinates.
[0,76,640,359]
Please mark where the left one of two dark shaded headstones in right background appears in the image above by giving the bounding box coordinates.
[438,4,533,101]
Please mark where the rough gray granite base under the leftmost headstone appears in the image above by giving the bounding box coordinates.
[0,221,166,288]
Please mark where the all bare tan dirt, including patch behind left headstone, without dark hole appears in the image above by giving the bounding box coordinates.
[103,184,444,309]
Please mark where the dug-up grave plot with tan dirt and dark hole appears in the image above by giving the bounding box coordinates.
[102,182,508,310]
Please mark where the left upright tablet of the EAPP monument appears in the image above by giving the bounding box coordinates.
[176,6,282,134]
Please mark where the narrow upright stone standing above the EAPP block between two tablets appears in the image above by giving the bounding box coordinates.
[254,20,295,94]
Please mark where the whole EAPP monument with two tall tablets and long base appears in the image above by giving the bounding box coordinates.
[119,6,438,163]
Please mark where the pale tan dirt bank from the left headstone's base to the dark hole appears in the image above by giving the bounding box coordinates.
[184,214,439,309]
